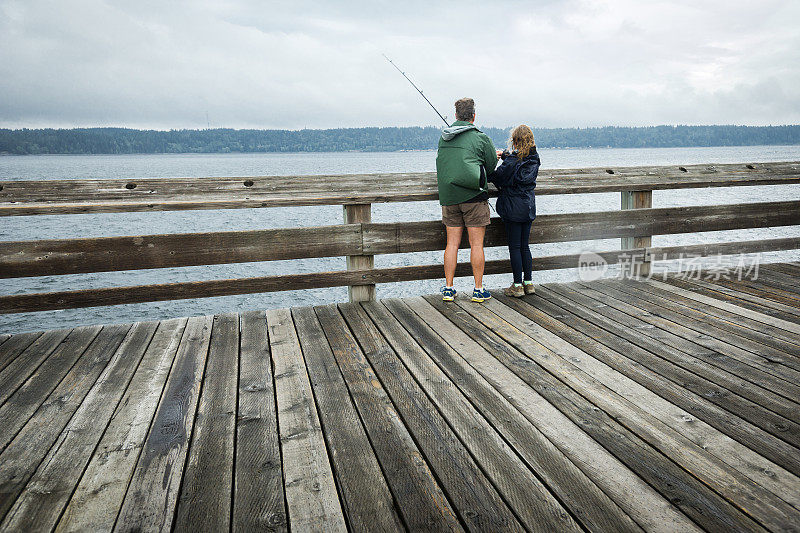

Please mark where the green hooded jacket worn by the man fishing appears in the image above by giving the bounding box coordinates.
[436,120,497,205]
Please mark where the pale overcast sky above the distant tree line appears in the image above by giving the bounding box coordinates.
[0,0,800,129]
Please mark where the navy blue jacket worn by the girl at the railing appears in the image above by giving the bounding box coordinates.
[489,150,540,222]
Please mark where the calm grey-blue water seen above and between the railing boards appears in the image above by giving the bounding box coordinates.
[0,146,800,333]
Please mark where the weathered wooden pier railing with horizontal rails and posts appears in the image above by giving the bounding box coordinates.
[0,162,800,313]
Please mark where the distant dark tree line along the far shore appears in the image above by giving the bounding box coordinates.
[0,125,800,155]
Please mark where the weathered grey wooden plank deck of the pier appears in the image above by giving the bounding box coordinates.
[0,263,800,532]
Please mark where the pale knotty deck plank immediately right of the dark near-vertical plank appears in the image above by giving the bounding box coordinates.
[267,309,347,531]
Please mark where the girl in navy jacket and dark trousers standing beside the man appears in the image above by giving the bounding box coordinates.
[489,124,540,298]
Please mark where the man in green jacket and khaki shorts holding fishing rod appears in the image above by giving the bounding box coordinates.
[436,98,497,302]
